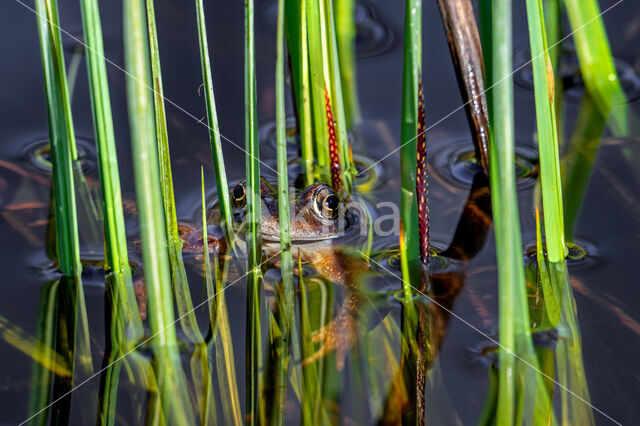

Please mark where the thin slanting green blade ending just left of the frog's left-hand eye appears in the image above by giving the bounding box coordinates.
[196,0,234,245]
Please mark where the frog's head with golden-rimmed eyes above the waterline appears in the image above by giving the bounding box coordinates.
[230,178,359,243]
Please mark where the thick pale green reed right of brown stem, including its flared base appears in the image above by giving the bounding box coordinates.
[489,0,551,425]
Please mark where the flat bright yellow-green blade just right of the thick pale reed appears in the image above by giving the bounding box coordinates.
[527,0,565,262]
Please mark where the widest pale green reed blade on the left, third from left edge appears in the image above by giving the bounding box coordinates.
[124,0,194,425]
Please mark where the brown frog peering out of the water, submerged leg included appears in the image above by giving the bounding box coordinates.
[222,177,369,370]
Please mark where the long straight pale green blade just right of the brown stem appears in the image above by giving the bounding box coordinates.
[489,0,528,425]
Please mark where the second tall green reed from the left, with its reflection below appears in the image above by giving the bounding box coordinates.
[80,0,143,425]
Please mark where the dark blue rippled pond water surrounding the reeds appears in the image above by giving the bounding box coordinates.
[0,0,640,424]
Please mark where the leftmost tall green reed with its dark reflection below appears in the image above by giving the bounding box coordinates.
[35,0,97,421]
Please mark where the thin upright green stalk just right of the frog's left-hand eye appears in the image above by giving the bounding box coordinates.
[244,0,262,424]
